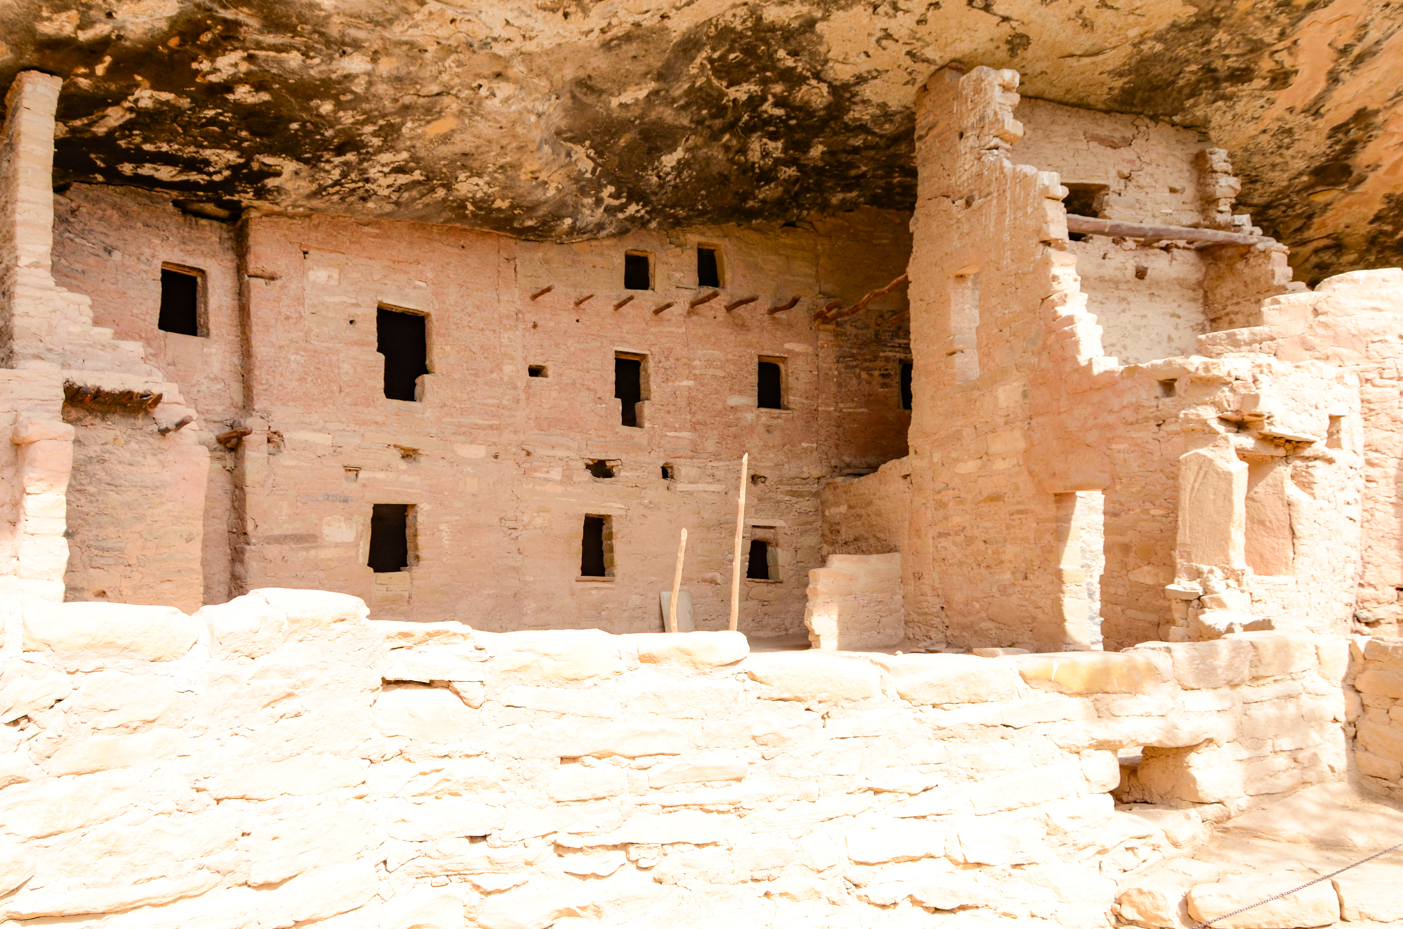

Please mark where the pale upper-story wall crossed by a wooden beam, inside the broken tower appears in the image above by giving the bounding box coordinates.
[1012,100,1291,365]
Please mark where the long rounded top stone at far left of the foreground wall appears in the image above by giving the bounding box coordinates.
[24,602,203,668]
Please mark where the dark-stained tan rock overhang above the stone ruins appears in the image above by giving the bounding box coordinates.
[0,0,1403,279]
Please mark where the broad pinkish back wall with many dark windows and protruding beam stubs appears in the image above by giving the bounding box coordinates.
[220,210,909,634]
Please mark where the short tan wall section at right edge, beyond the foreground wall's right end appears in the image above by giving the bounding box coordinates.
[1351,637,1403,800]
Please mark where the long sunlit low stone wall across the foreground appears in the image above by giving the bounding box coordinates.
[0,589,1348,929]
